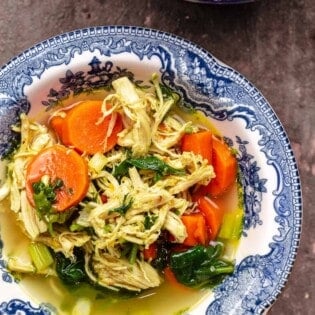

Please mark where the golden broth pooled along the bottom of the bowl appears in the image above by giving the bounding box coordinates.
[21,277,210,315]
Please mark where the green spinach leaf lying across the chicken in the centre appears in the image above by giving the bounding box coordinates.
[114,155,185,179]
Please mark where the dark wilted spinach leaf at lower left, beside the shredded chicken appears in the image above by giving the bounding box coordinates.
[56,247,88,285]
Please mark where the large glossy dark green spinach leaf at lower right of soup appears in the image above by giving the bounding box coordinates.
[170,243,234,287]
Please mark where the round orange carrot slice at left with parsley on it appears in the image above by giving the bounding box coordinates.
[26,144,89,211]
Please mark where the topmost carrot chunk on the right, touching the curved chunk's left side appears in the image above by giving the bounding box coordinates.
[181,131,212,164]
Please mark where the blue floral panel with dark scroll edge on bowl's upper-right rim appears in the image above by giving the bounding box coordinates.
[178,50,257,128]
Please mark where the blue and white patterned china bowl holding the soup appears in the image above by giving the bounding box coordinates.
[0,26,302,315]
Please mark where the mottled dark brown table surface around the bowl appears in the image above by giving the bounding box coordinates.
[0,0,315,315]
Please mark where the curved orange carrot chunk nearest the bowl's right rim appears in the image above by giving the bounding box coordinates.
[200,137,237,197]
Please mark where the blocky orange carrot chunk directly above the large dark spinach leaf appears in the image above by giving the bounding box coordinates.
[181,213,208,246]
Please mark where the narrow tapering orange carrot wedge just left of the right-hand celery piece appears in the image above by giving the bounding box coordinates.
[198,197,224,240]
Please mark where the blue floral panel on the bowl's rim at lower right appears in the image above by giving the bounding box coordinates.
[206,244,286,315]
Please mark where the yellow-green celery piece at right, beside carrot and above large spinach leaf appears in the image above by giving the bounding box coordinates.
[219,208,244,240]
